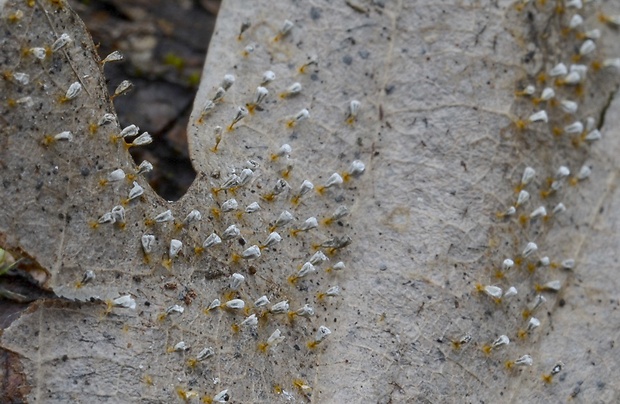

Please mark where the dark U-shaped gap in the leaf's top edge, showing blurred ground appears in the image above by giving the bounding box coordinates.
[71,0,219,201]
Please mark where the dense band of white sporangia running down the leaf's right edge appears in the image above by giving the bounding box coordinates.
[464,0,620,383]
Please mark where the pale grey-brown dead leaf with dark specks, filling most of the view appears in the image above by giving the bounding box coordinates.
[0,0,620,403]
